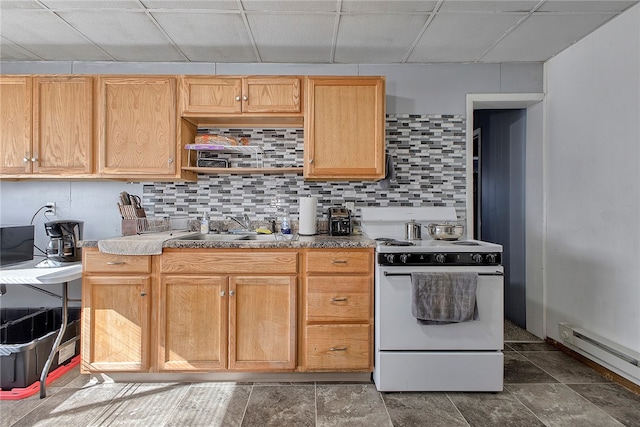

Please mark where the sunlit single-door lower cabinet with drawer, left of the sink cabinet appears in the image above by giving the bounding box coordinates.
[81,250,151,372]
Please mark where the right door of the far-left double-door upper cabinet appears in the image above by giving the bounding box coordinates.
[33,76,93,175]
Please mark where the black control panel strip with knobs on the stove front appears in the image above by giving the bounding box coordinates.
[378,252,502,266]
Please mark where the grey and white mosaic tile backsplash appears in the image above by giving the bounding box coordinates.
[142,114,466,226]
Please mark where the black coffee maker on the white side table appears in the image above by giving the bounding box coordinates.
[38,220,83,267]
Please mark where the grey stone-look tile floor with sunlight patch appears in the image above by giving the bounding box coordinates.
[0,325,640,427]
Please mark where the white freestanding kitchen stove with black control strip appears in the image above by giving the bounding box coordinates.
[361,207,504,392]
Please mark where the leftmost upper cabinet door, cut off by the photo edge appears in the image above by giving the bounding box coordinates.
[0,76,33,174]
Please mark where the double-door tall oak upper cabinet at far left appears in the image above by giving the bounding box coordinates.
[0,75,93,178]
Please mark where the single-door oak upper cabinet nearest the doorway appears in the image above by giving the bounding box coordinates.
[304,76,385,180]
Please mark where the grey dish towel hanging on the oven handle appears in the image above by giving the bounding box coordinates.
[411,272,478,325]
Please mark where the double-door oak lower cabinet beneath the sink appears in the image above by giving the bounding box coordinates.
[157,250,298,371]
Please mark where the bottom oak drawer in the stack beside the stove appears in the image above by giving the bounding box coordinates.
[307,325,372,371]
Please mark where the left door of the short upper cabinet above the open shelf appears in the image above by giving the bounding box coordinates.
[180,76,242,115]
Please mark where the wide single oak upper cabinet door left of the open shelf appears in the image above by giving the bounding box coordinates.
[97,76,178,179]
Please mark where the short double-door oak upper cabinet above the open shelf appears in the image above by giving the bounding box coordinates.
[181,76,302,116]
